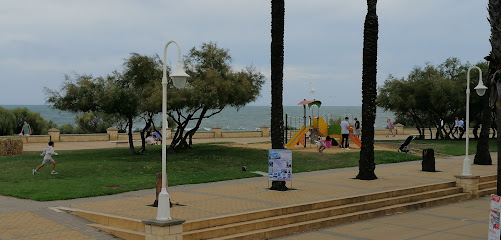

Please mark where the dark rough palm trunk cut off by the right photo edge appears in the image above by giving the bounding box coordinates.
[485,0,501,195]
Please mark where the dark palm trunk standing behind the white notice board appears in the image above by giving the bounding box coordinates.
[271,0,287,191]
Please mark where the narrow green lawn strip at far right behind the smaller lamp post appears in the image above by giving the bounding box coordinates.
[378,139,497,156]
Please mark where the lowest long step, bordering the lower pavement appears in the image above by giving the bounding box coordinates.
[214,193,469,240]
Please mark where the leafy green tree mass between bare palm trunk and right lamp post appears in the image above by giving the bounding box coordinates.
[377,58,486,139]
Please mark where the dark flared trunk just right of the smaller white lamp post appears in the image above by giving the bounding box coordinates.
[473,65,496,165]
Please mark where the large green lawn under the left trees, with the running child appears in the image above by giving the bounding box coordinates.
[0,144,419,201]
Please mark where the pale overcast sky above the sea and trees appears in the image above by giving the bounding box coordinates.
[0,0,490,106]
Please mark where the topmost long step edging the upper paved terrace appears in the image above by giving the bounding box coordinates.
[183,182,456,232]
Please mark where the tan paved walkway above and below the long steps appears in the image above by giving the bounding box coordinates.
[0,136,497,240]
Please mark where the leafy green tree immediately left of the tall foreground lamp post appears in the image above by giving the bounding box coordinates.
[46,53,161,154]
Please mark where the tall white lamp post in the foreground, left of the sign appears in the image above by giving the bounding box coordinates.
[157,41,189,221]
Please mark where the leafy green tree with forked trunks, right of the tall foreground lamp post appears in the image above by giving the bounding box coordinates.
[167,43,264,150]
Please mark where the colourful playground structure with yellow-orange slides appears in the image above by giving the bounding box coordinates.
[285,99,362,149]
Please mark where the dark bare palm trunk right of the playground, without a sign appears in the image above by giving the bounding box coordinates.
[356,0,379,180]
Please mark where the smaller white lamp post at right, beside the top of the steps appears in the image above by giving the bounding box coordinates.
[462,66,487,176]
